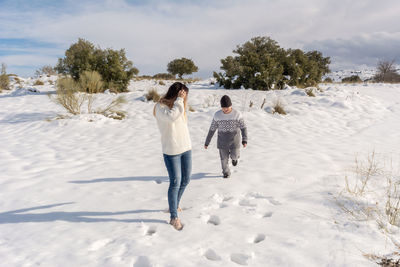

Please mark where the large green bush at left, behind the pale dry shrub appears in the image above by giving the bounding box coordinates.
[56,39,139,92]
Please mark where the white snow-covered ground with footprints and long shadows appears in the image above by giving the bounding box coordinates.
[0,78,400,267]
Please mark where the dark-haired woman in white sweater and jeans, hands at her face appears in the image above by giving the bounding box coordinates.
[153,82,192,230]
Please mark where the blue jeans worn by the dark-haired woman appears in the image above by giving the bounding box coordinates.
[163,150,192,219]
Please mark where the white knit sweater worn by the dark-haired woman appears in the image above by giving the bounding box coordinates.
[155,97,192,155]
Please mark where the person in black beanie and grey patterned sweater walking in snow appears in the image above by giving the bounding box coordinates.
[204,95,247,178]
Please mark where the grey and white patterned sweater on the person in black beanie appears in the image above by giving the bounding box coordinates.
[205,109,247,149]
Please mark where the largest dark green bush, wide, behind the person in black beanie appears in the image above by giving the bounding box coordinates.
[214,37,330,90]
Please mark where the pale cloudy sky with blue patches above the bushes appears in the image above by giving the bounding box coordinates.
[0,0,400,78]
